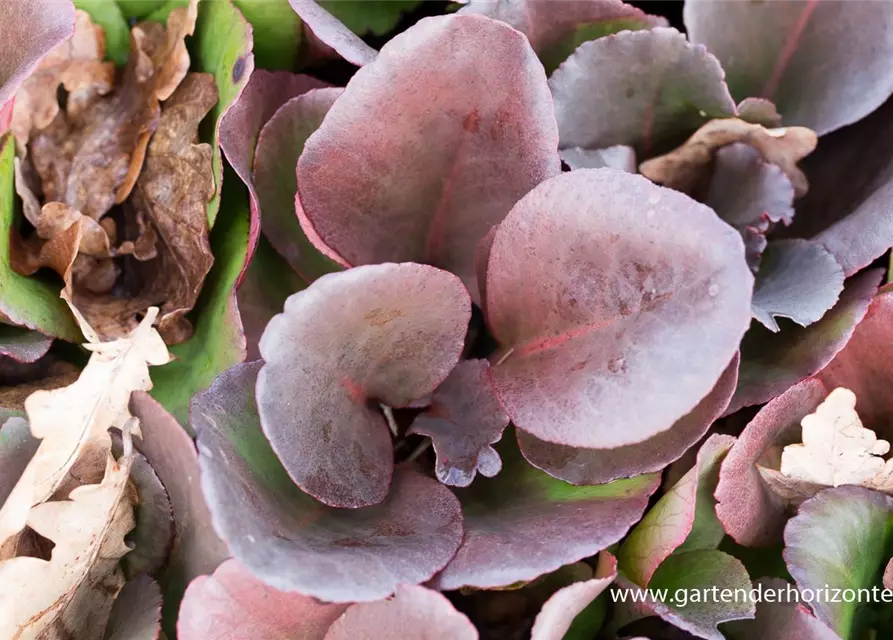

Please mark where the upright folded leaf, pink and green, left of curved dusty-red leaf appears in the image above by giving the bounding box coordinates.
[617,434,735,587]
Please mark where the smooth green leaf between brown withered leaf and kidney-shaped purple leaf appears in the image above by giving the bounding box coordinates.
[152,170,250,426]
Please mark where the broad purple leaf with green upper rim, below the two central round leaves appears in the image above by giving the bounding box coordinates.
[433,438,660,590]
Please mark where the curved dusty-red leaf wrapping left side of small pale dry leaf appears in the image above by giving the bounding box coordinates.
[715,379,828,547]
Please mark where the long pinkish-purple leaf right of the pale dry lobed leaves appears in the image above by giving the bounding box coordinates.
[132,392,230,623]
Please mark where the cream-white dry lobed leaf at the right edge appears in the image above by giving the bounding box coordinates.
[758,387,893,504]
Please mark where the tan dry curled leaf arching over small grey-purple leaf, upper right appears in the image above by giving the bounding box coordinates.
[639,118,818,197]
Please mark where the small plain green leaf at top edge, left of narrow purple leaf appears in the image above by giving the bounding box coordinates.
[233,0,303,70]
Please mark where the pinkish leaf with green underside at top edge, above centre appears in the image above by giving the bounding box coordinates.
[459,0,667,72]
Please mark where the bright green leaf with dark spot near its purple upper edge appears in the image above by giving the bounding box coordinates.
[148,0,254,226]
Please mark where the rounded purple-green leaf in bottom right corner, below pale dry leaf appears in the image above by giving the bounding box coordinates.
[784,486,893,640]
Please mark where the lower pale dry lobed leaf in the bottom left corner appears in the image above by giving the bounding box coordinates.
[0,453,134,640]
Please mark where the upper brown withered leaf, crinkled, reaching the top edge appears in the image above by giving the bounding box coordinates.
[29,0,197,220]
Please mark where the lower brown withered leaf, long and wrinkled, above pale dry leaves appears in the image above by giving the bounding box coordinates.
[72,73,217,344]
